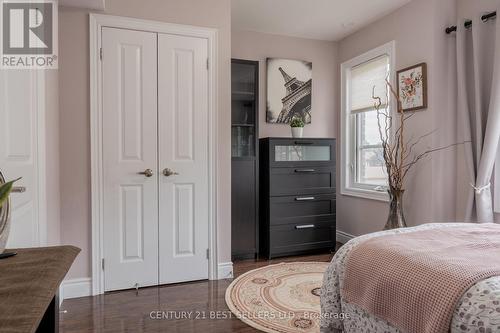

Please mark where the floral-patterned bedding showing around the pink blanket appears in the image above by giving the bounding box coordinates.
[321,223,500,333]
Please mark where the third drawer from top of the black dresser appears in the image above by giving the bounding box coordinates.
[269,194,335,225]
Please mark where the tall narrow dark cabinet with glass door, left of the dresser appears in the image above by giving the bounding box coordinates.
[231,59,259,260]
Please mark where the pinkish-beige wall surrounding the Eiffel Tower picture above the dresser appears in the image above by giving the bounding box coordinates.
[231,30,339,138]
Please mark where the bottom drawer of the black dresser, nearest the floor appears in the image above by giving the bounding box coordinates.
[269,222,335,256]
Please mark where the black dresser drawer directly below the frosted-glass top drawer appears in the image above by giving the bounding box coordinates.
[269,167,335,196]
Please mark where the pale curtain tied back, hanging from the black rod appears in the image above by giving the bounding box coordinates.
[457,13,500,223]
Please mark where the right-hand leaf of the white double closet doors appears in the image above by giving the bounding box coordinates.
[158,34,209,283]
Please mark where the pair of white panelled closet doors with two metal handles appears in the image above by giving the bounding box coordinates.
[102,28,209,291]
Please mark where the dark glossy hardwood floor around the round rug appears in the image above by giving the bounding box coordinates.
[60,253,333,333]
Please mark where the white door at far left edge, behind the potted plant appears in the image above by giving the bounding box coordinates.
[0,70,46,248]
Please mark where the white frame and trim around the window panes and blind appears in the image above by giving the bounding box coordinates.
[340,41,396,202]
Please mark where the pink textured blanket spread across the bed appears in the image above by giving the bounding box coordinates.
[341,224,500,333]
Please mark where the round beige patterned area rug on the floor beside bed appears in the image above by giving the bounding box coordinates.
[226,262,328,333]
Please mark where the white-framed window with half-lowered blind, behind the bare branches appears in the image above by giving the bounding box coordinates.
[341,42,394,200]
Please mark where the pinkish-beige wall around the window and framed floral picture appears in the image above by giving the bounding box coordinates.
[337,0,456,235]
